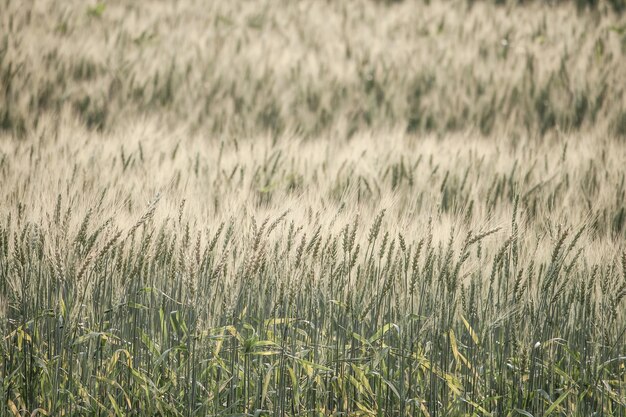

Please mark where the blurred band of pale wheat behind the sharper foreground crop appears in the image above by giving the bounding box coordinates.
[0,0,626,137]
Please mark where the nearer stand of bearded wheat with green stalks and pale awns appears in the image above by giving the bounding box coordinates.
[0,122,626,416]
